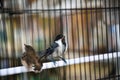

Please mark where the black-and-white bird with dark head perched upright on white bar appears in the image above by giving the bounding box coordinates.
[40,34,67,64]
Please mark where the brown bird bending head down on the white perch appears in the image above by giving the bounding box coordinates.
[21,44,43,72]
